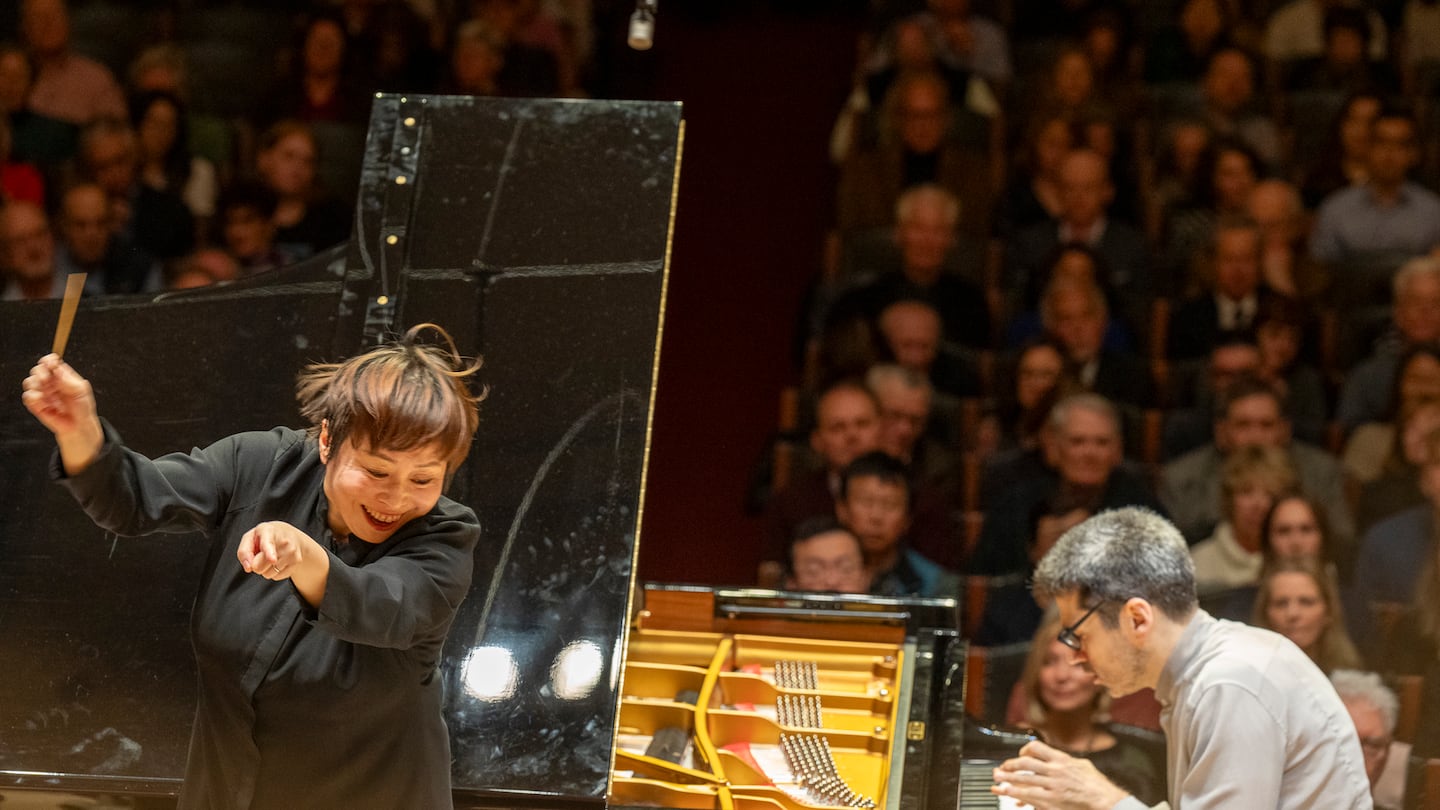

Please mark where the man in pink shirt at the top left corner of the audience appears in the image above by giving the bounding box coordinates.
[20,0,125,125]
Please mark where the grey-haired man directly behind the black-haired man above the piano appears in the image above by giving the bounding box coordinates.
[865,363,960,568]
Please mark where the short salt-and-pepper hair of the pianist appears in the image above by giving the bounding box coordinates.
[1035,507,1198,627]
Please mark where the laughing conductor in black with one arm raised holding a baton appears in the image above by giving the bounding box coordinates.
[22,324,480,810]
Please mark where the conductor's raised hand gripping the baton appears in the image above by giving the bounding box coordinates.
[20,355,105,476]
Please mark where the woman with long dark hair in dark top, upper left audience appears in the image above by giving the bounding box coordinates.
[130,92,219,236]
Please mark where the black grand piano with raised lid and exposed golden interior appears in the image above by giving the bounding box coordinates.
[0,95,1004,810]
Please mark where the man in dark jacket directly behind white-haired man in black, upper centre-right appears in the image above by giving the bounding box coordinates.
[837,74,995,238]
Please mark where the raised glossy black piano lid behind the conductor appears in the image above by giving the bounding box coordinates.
[0,95,681,806]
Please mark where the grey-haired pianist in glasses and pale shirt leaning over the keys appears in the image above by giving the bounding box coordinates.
[992,509,1371,810]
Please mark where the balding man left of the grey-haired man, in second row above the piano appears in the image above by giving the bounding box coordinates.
[766,380,880,559]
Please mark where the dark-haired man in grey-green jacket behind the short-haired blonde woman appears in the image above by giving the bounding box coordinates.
[1161,378,1355,550]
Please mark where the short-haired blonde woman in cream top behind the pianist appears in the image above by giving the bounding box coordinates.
[1191,445,1295,594]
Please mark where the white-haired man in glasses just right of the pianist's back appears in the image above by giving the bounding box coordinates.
[1331,669,1410,810]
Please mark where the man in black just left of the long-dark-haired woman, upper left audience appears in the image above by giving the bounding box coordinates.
[79,118,196,261]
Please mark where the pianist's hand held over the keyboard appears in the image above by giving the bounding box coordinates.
[991,741,1129,810]
